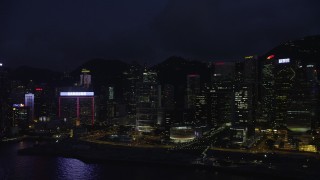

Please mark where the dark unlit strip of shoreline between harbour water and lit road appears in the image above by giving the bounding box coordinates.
[18,142,319,179]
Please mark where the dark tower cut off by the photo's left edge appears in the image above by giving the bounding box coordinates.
[0,62,9,137]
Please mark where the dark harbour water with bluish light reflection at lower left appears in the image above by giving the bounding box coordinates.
[0,141,257,180]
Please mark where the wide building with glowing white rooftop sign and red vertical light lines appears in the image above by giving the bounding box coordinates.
[58,92,95,126]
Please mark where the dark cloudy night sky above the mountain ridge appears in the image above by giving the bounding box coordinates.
[0,0,320,70]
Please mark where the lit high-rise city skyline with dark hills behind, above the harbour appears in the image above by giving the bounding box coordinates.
[0,51,320,177]
